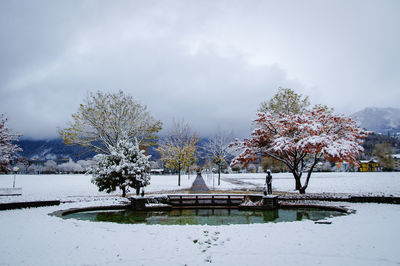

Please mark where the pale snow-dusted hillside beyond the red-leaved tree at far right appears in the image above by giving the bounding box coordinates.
[351,107,400,135]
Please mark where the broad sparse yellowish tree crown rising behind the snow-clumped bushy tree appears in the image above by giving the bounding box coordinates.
[59,91,162,154]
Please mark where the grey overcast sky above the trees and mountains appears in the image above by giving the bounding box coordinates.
[0,0,400,138]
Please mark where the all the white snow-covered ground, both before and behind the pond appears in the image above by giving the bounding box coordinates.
[0,173,400,265]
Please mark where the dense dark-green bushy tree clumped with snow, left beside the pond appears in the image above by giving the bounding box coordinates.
[91,138,150,197]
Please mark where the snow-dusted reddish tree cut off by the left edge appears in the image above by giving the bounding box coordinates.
[0,114,22,173]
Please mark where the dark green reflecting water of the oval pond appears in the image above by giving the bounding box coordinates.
[63,208,345,225]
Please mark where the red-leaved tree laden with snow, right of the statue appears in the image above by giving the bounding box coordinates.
[231,106,368,194]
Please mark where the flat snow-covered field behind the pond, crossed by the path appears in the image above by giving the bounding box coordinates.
[0,172,400,203]
